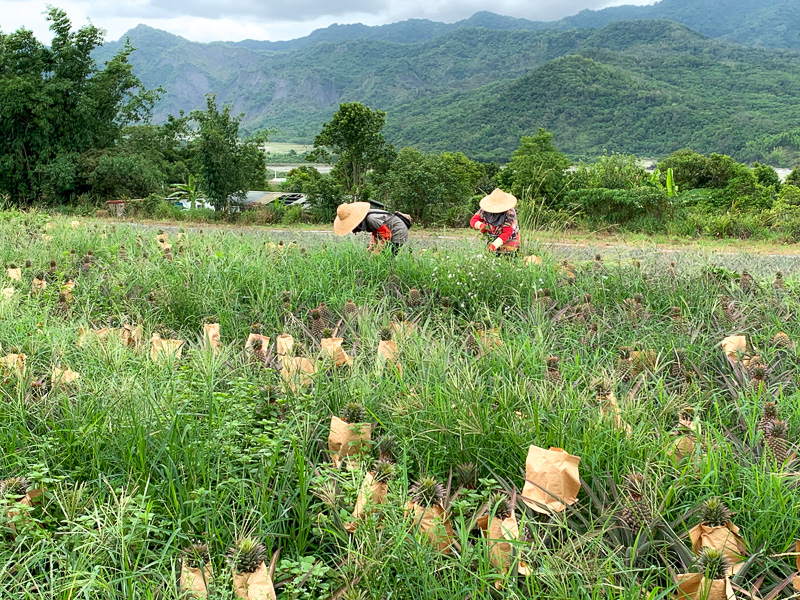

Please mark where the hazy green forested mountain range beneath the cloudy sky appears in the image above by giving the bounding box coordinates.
[98,0,800,162]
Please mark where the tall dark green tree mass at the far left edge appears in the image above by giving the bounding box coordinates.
[0,7,159,203]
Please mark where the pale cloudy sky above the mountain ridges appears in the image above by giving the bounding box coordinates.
[0,0,655,42]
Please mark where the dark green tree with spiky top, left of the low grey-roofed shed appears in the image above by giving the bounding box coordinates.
[191,94,267,211]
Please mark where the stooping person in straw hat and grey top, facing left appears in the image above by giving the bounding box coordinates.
[333,202,408,254]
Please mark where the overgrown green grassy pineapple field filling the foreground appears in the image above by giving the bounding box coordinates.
[0,212,800,600]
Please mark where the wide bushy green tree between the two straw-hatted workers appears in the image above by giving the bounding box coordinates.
[379,148,472,224]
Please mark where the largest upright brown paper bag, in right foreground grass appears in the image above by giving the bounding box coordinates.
[522,446,581,514]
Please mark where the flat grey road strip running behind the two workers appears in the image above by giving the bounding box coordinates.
[111,221,800,278]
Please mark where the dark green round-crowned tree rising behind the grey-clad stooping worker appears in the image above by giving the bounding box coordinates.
[307,102,395,202]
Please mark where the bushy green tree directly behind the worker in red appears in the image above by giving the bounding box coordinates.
[496,127,571,206]
